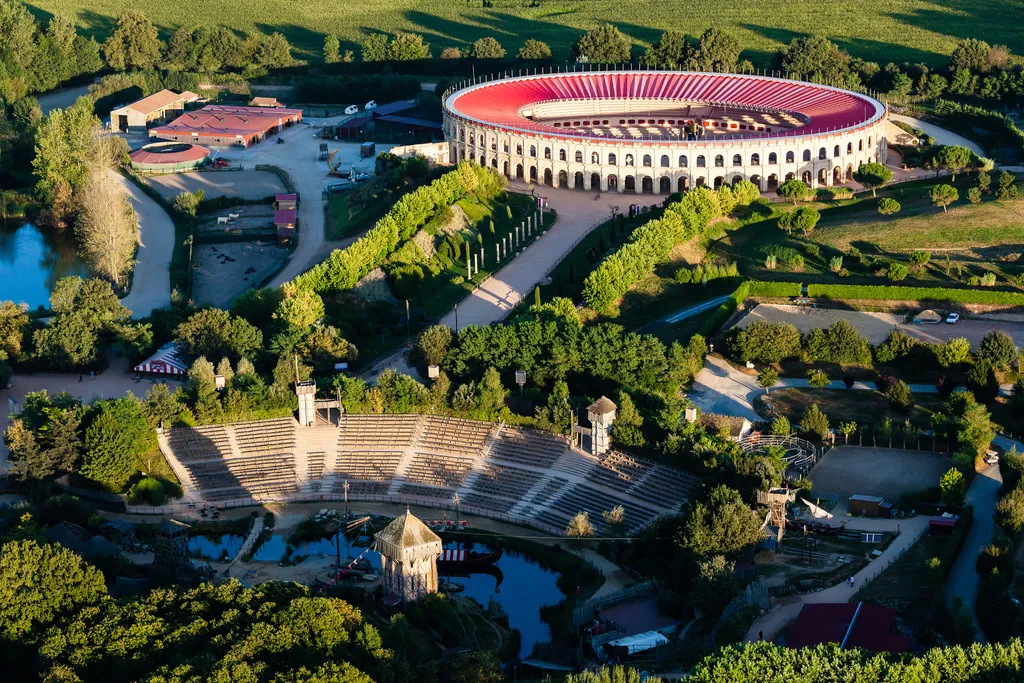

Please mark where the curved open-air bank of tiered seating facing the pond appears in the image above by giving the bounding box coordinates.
[159,415,699,533]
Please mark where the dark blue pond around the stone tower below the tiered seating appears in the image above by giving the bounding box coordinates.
[253,533,565,658]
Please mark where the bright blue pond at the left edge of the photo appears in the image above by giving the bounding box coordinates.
[0,221,89,309]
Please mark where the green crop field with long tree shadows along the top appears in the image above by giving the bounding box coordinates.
[30,0,1024,67]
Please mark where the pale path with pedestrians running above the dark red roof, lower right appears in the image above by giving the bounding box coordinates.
[746,515,928,642]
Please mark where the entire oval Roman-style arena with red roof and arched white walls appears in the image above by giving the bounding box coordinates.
[443,71,887,194]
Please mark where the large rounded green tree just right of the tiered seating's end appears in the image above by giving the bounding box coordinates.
[676,484,763,558]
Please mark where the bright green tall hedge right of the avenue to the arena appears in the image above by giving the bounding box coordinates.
[583,187,721,310]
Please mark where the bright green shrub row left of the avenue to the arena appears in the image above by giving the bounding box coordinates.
[293,162,506,294]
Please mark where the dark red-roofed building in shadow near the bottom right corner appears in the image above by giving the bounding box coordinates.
[785,602,910,652]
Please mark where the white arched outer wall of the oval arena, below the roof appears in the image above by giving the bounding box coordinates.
[443,73,888,195]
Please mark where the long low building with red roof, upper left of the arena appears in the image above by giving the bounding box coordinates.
[150,104,302,147]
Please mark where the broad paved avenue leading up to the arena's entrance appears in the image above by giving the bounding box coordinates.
[369,182,665,375]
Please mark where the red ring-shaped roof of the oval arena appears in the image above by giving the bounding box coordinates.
[445,71,885,140]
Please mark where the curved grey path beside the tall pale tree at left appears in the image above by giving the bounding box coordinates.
[119,171,174,318]
